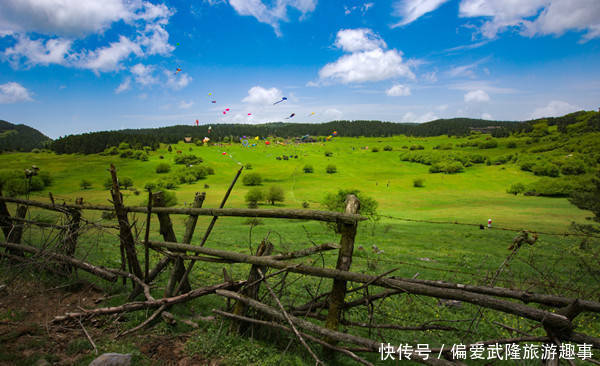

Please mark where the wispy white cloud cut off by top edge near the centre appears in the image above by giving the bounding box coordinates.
[229,0,317,37]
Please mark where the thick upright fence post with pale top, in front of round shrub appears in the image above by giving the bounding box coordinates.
[325,194,360,343]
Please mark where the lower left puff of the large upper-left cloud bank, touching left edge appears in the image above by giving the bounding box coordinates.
[3,35,72,68]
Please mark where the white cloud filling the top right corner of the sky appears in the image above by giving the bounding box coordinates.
[459,0,600,40]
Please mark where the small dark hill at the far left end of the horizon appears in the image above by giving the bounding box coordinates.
[0,120,51,151]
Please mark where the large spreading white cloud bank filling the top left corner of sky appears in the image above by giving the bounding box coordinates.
[0,0,174,73]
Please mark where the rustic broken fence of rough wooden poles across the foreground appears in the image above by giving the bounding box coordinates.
[0,166,600,365]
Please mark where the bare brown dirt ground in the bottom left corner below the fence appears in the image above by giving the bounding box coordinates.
[0,278,212,366]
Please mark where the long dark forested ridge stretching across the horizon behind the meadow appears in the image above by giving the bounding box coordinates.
[51,118,531,154]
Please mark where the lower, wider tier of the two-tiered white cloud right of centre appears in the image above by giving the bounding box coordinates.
[319,49,415,84]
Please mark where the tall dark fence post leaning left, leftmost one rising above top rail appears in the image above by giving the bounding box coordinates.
[110,164,144,287]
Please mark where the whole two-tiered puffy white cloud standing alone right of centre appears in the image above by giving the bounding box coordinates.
[319,29,415,84]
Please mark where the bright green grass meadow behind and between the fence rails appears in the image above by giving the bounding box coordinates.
[0,136,600,365]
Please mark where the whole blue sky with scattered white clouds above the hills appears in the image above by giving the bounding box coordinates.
[0,0,600,138]
